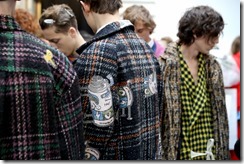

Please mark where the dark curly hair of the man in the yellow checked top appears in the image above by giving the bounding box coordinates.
[177,6,224,45]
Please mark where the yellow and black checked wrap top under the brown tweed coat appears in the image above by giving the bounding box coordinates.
[179,53,213,160]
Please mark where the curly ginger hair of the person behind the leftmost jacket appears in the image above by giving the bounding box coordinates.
[14,9,42,38]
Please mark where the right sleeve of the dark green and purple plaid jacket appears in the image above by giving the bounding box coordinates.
[53,49,85,160]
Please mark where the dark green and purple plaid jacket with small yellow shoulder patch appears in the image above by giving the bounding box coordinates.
[0,15,84,160]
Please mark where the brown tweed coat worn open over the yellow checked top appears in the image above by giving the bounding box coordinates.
[160,43,230,160]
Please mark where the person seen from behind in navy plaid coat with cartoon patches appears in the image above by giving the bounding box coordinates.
[74,0,162,160]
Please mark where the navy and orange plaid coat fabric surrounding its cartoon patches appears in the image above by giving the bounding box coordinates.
[74,20,161,160]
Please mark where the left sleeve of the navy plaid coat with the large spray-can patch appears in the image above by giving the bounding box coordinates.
[75,42,117,160]
